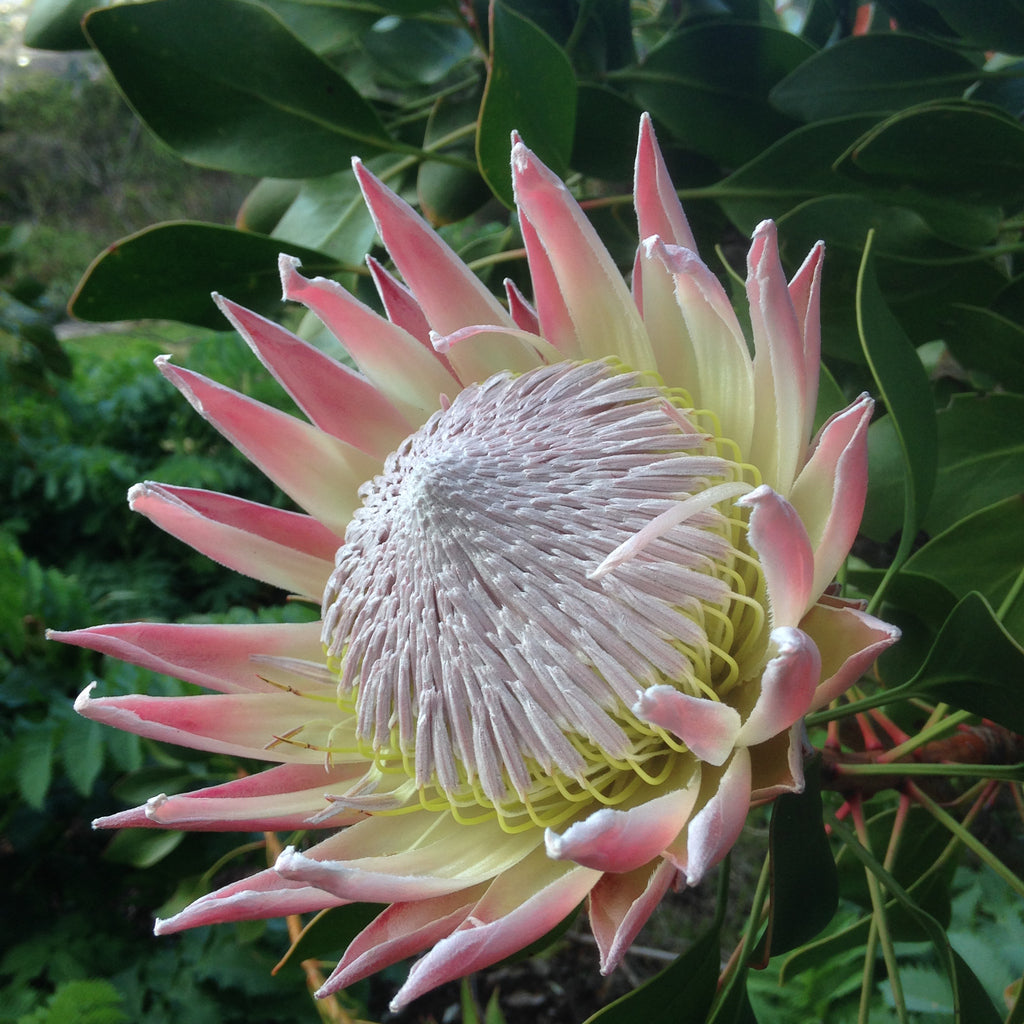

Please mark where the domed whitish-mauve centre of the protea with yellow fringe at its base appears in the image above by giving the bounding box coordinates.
[323,361,765,830]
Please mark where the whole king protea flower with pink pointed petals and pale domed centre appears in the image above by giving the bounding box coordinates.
[49,118,897,1007]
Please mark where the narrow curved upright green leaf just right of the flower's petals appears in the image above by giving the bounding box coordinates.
[857,238,937,577]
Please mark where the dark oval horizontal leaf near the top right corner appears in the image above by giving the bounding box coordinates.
[771,32,980,121]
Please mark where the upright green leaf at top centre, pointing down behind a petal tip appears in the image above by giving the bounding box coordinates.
[476,0,577,207]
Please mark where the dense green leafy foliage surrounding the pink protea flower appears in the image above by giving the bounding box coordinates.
[6,0,1024,1024]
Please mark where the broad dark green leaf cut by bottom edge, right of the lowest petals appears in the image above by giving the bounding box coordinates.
[586,927,721,1024]
